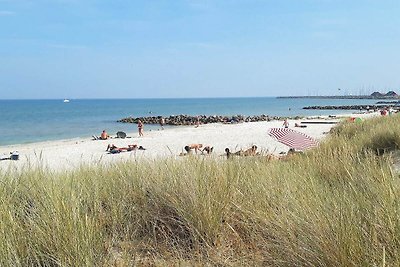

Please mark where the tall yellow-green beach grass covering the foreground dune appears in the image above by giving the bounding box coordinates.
[0,116,400,266]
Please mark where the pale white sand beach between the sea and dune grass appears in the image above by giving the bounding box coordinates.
[0,113,377,171]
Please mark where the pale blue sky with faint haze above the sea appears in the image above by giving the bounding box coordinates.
[0,0,400,99]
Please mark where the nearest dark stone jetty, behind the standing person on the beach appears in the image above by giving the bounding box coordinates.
[118,114,301,126]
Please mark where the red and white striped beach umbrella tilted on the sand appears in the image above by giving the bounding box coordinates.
[268,128,318,150]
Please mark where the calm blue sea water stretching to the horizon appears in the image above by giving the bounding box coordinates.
[0,97,376,145]
